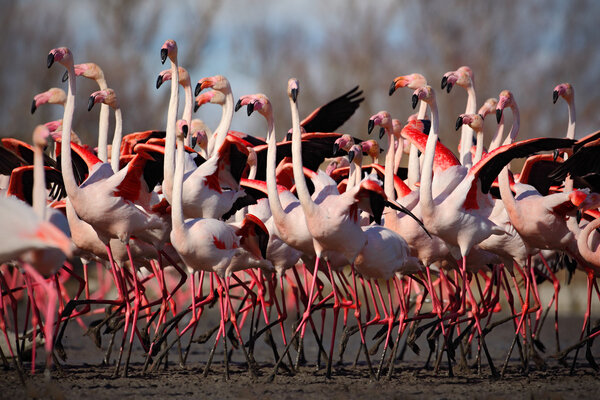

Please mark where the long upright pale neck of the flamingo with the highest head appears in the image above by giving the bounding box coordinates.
[163,57,179,193]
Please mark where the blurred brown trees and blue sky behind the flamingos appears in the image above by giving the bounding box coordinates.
[0,0,600,158]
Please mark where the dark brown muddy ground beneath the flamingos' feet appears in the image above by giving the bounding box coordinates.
[0,315,600,400]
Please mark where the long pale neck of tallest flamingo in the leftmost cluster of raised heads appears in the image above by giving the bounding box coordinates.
[60,62,79,199]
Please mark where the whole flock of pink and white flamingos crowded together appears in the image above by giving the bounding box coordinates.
[0,40,600,379]
